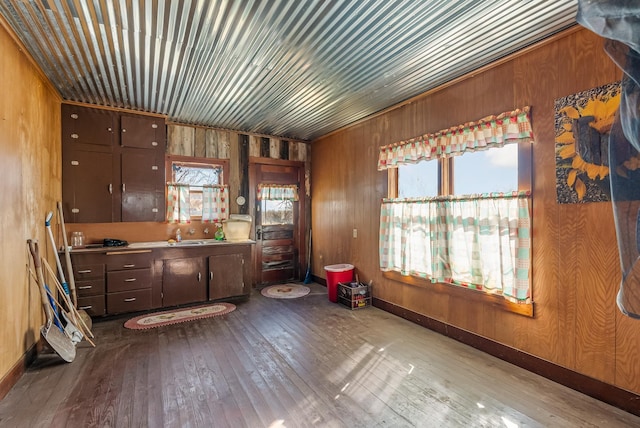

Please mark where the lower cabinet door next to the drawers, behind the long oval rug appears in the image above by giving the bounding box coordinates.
[162,257,207,307]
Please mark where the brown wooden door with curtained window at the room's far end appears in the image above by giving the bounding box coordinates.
[250,160,305,285]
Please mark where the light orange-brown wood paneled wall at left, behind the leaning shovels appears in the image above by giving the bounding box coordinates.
[0,17,61,392]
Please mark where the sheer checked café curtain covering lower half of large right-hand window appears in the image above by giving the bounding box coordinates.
[379,192,531,303]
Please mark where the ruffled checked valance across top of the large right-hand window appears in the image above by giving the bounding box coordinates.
[378,106,533,171]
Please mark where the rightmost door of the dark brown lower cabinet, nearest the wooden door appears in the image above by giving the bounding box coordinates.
[209,254,247,300]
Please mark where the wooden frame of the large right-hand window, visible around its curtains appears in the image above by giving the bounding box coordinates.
[382,142,534,317]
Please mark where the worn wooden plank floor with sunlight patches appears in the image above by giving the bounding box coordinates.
[0,284,640,428]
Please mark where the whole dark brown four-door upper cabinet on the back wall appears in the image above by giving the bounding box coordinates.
[62,104,166,223]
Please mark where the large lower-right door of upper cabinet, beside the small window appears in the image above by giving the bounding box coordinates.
[121,148,165,221]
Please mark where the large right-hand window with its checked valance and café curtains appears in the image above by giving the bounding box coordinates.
[379,110,533,314]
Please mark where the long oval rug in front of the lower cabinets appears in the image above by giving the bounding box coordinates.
[124,303,236,330]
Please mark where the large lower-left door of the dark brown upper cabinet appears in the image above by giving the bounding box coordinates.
[62,150,114,223]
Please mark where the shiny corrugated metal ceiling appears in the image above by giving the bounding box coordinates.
[0,0,577,140]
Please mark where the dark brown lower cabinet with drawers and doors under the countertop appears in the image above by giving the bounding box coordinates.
[71,242,253,316]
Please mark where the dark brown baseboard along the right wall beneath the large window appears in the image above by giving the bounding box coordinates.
[372,297,640,416]
